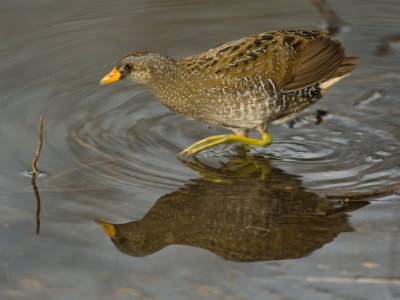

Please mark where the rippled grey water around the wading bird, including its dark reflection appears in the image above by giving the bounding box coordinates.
[0,0,400,299]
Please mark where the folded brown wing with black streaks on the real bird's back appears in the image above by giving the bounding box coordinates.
[181,30,332,93]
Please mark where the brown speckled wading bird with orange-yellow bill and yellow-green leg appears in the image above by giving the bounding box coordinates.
[100,29,359,156]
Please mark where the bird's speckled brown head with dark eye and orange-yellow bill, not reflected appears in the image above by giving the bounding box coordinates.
[100,51,170,84]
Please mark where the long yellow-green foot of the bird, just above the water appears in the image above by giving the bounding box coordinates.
[178,132,272,156]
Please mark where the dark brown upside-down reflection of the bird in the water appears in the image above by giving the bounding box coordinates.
[96,155,367,262]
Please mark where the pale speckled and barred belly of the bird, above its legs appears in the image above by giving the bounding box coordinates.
[153,85,321,129]
